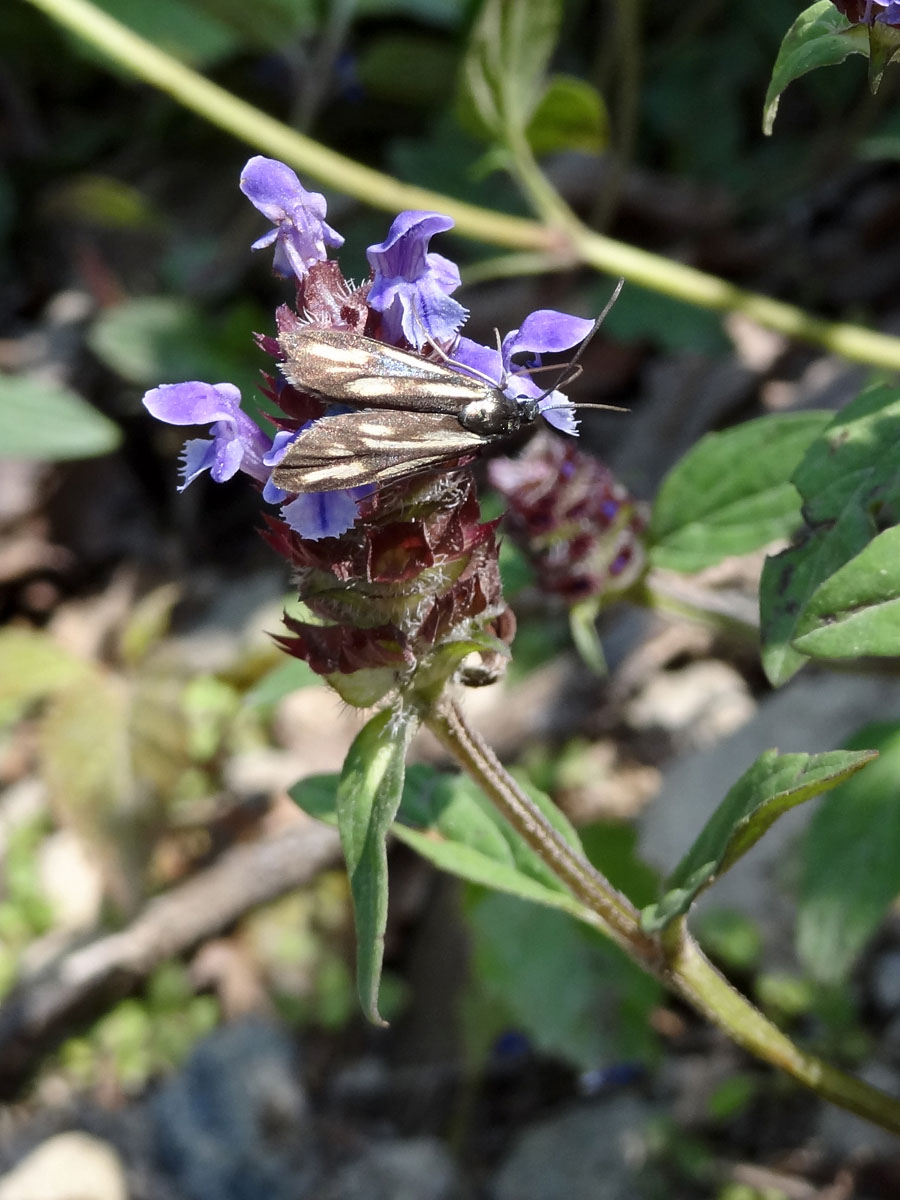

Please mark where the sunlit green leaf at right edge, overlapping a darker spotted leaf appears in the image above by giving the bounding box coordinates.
[793,526,900,659]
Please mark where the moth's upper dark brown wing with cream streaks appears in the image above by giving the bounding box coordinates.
[278,325,493,414]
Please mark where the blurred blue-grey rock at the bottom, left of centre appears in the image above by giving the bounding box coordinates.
[150,1020,318,1200]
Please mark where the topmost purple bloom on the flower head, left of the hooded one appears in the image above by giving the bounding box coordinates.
[241,155,343,280]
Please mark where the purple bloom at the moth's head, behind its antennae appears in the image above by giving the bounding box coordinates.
[454,308,594,434]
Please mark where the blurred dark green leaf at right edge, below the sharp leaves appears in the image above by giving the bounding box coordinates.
[797,722,900,984]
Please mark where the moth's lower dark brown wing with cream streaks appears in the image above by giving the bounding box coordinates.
[272,412,493,492]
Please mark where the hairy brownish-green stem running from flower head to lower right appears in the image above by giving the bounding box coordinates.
[426,702,900,1134]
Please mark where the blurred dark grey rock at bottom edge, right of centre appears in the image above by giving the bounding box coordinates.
[490,1094,652,1200]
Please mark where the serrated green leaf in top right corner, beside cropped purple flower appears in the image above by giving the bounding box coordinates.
[762,0,869,134]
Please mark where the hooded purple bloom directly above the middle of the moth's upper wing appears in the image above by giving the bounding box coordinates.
[366,210,468,349]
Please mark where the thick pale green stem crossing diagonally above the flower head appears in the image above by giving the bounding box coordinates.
[28,0,900,371]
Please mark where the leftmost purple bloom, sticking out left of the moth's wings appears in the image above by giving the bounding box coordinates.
[144,380,270,491]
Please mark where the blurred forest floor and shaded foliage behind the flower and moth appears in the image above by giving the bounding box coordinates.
[0,0,900,1200]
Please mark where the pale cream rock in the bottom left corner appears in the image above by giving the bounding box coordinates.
[0,1133,128,1200]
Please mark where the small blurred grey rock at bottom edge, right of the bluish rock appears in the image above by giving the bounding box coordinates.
[317,1138,462,1200]
